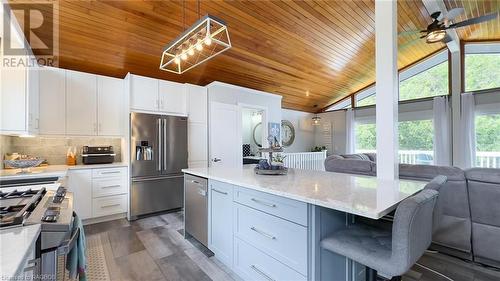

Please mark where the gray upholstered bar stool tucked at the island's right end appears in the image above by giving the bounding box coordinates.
[321,177,446,281]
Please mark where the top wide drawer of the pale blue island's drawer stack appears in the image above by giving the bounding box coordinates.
[234,186,307,226]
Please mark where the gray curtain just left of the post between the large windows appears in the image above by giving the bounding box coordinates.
[432,97,451,166]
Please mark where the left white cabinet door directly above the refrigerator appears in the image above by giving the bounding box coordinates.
[130,75,159,111]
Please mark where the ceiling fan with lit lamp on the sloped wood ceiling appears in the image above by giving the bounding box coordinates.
[404,8,498,44]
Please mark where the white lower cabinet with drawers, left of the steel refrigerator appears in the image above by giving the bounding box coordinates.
[68,167,128,219]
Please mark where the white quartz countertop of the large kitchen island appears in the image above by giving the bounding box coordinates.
[182,165,426,219]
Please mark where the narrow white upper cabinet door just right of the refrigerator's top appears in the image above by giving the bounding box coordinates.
[185,84,208,124]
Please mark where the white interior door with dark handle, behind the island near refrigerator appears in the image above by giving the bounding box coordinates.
[209,102,242,168]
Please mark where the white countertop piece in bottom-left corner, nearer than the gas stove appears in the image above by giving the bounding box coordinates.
[0,224,40,280]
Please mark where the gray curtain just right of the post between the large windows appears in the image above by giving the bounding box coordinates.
[460,93,476,168]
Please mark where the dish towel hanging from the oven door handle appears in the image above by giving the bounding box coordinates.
[66,214,87,281]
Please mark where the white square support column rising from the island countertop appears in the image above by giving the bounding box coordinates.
[375,0,399,180]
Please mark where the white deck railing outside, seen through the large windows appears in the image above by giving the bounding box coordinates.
[357,149,500,168]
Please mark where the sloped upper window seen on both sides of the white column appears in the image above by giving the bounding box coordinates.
[355,51,448,107]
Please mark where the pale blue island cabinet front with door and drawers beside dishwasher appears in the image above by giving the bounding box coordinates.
[208,180,311,281]
